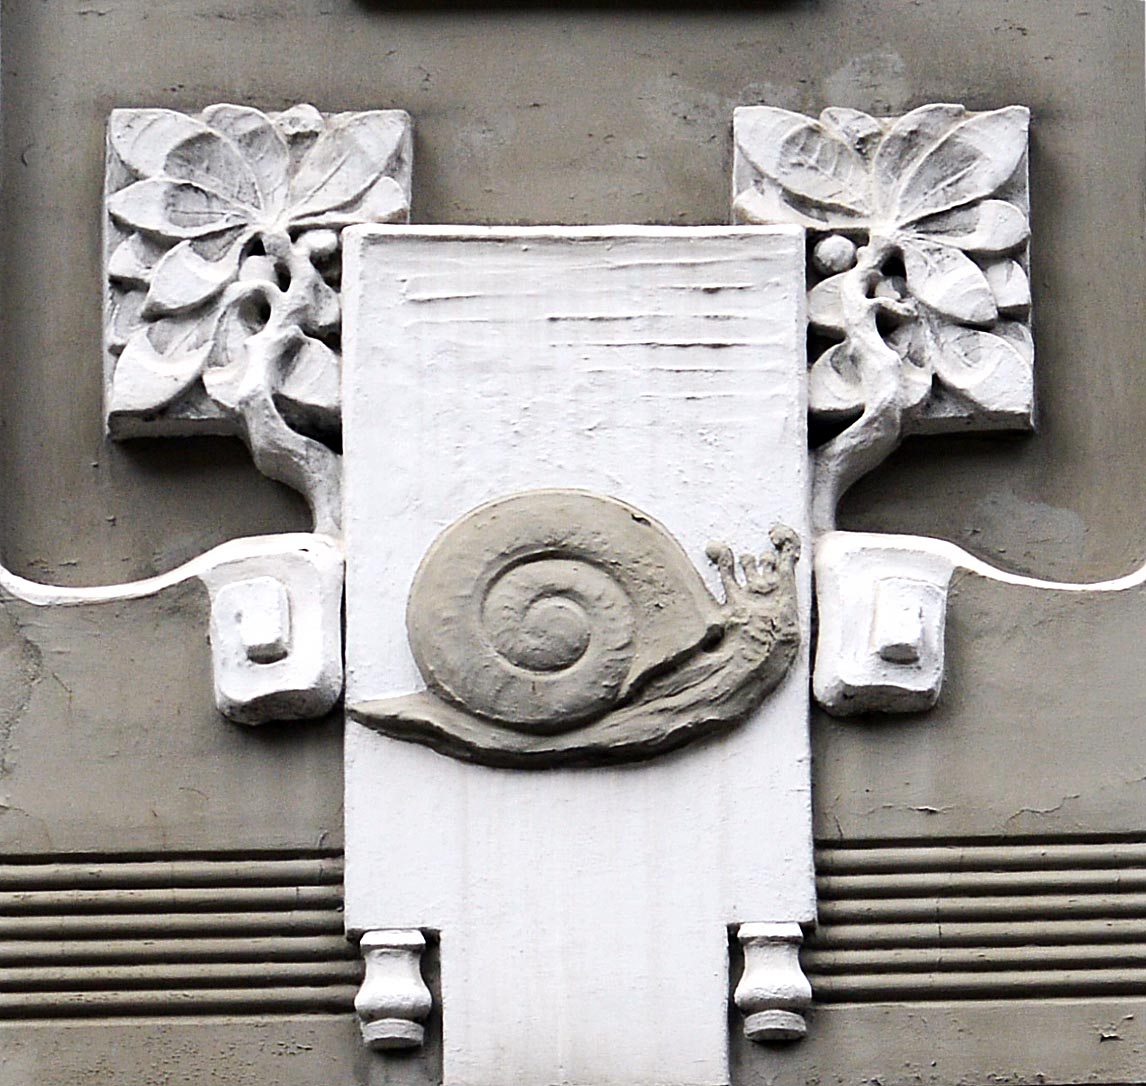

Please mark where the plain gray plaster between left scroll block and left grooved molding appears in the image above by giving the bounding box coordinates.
[0,582,342,856]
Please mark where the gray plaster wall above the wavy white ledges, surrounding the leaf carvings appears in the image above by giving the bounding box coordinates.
[0,0,1146,583]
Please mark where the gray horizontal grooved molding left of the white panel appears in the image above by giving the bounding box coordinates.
[0,851,362,1021]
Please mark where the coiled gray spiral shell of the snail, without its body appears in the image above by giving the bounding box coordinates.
[407,490,723,735]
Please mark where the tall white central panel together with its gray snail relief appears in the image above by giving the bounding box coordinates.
[343,227,815,1086]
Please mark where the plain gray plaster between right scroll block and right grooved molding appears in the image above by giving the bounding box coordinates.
[813,574,1146,841]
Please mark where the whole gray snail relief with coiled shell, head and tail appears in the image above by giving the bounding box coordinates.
[351,490,800,766]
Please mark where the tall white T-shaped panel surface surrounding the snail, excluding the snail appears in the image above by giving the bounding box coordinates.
[343,227,815,1086]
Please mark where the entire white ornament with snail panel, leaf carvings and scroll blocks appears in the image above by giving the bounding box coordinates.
[69,84,1139,1086]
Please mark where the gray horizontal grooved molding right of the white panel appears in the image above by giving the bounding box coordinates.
[801,841,1146,1002]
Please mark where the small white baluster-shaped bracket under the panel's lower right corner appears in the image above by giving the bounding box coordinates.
[733,923,811,1042]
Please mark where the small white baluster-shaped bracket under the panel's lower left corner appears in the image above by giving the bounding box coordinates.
[354,930,433,1050]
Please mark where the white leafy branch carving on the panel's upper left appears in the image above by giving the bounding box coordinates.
[105,104,411,533]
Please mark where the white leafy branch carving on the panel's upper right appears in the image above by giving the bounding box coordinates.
[733,104,1034,530]
